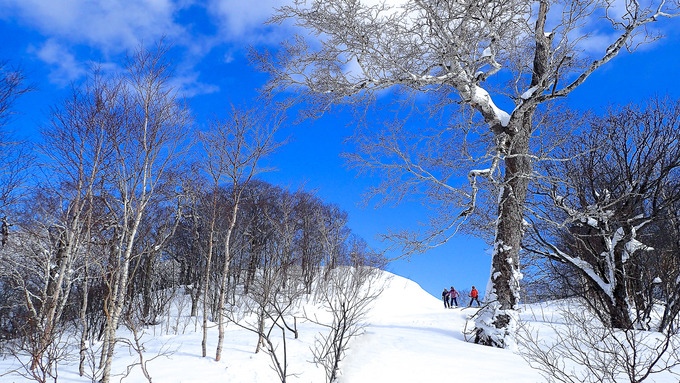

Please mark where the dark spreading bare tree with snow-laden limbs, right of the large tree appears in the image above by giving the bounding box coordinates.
[527,99,680,329]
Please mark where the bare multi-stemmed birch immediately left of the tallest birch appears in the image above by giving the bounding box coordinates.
[0,67,116,379]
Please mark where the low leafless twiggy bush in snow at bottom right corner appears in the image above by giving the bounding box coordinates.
[517,301,680,383]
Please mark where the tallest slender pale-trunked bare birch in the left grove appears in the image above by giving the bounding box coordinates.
[101,43,190,383]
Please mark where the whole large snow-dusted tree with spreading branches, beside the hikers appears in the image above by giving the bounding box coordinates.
[253,0,678,347]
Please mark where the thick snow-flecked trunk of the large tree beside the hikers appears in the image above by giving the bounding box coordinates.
[475,1,551,347]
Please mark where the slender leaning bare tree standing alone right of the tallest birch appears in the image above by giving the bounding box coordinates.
[202,107,282,361]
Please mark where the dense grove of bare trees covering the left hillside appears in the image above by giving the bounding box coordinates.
[0,44,383,382]
